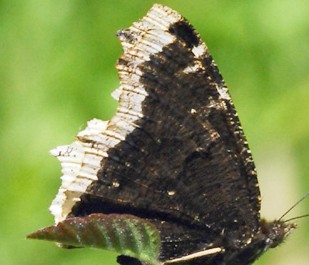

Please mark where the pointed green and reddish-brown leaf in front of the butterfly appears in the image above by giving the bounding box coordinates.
[27,214,160,265]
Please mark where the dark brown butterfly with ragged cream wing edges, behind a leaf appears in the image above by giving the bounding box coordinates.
[30,5,295,265]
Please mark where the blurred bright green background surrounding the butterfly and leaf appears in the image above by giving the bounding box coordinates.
[0,0,309,265]
